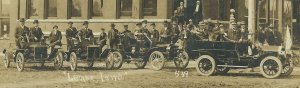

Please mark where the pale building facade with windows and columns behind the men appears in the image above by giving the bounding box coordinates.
[0,0,300,44]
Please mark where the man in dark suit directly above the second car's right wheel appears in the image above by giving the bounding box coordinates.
[107,24,119,49]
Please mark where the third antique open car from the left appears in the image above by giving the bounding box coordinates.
[109,33,155,69]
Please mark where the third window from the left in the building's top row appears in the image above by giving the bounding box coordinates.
[69,0,85,17]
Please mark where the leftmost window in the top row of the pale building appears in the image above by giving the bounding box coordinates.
[28,0,40,17]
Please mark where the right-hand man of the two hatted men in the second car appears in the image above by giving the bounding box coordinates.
[78,21,94,42]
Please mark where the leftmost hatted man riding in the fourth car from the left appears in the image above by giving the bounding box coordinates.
[160,21,172,43]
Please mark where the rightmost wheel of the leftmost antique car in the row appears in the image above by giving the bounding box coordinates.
[54,52,63,70]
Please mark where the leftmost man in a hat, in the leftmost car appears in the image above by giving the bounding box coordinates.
[15,18,30,48]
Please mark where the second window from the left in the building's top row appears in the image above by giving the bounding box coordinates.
[46,0,57,17]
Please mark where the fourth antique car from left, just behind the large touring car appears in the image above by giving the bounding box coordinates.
[149,40,189,70]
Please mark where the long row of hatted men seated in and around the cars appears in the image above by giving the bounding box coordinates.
[15,18,282,55]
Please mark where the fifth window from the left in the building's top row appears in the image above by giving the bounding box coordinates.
[120,0,132,16]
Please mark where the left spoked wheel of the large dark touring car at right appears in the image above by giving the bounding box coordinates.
[196,55,216,76]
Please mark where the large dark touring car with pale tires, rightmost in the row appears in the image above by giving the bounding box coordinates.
[190,40,293,78]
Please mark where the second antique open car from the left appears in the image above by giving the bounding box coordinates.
[66,38,113,71]
